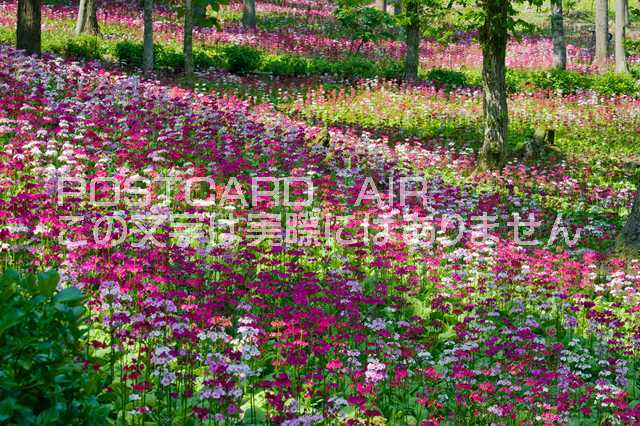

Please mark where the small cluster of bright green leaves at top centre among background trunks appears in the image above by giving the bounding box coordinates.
[335,0,394,53]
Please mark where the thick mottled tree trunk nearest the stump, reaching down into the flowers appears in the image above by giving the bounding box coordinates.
[478,0,509,170]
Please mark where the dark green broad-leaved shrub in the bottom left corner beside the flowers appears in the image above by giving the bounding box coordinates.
[0,270,109,425]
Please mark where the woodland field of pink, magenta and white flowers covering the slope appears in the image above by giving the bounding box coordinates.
[0,1,640,426]
